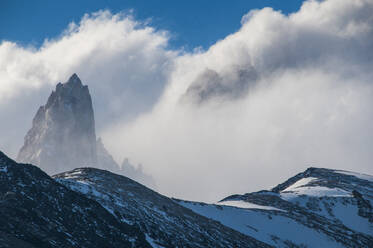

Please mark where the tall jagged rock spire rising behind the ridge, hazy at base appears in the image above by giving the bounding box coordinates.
[17,74,97,174]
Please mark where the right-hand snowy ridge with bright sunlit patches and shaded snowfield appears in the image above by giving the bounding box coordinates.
[178,168,373,247]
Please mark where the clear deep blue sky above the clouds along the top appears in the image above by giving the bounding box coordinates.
[0,0,303,50]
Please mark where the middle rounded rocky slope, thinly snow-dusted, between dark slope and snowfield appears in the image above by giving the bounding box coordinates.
[54,168,269,248]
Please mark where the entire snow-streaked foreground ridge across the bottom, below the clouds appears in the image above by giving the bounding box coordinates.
[0,148,373,248]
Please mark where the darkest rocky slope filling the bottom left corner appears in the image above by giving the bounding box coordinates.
[0,152,151,247]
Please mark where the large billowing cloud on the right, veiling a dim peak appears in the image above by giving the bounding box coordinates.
[100,0,373,201]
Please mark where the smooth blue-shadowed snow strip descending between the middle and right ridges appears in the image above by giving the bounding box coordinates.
[179,201,343,248]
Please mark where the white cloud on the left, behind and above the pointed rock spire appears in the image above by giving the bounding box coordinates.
[0,11,177,156]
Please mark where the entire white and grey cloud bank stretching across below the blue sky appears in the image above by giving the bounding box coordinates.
[0,0,373,201]
